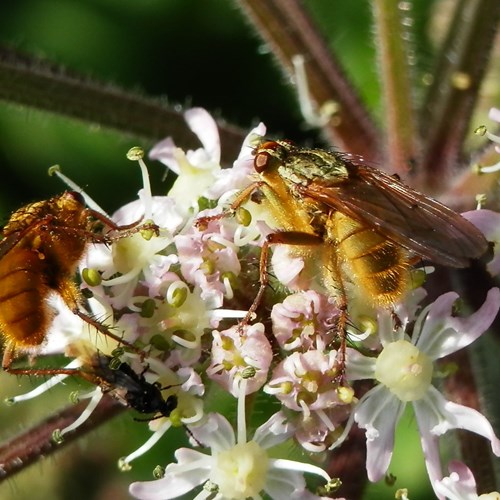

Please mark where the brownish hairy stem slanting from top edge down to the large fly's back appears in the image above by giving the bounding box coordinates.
[234,0,380,159]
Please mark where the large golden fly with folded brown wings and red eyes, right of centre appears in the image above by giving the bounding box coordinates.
[197,141,488,364]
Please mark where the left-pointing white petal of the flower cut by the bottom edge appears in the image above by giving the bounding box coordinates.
[129,448,210,500]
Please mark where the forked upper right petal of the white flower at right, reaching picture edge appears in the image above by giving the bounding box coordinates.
[415,288,500,360]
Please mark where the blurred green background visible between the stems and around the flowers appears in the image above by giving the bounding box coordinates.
[0,0,480,500]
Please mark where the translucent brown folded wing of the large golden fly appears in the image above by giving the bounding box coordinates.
[297,165,488,267]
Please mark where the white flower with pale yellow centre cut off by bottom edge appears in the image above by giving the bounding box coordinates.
[130,381,330,500]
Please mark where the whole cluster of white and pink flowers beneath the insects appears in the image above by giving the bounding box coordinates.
[6,109,500,499]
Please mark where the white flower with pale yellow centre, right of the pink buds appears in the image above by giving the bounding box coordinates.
[347,288,500,498]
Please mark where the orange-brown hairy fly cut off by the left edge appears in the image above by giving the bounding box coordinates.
[0,191,157,374]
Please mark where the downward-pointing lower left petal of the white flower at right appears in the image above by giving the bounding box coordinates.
[354,384,405,481]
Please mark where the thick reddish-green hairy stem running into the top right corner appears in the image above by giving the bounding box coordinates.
[420,0,500,191]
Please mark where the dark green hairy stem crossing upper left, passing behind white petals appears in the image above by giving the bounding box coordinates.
[0,48,245,163]
